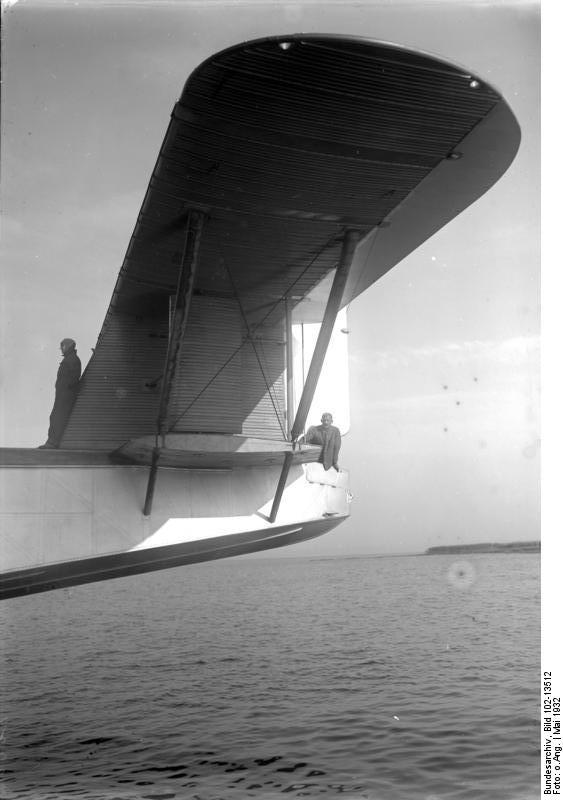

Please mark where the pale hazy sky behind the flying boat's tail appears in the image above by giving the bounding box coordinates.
[0,0,539,554]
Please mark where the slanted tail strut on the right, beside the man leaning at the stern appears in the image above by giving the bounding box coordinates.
[269,230,360,522]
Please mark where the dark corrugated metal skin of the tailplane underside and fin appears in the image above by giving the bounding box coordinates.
[63,36,500,448]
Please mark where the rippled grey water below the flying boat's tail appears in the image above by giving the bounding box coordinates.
[0,554,540,800]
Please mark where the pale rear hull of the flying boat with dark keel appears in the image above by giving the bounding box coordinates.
[0,456,349,599]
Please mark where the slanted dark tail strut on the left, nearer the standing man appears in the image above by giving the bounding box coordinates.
[143,210,204,517]
